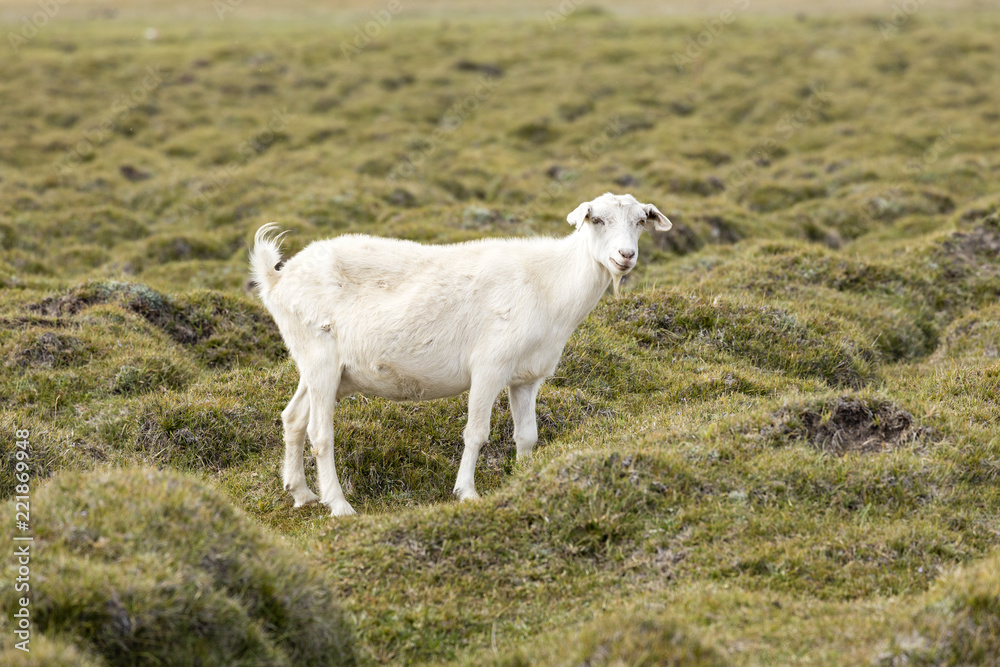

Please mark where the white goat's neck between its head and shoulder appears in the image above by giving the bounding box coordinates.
[549,231,611,336]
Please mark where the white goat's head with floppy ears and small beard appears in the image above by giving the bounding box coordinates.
[566,192,672,292]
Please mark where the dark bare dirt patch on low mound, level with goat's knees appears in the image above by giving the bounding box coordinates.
[763,396,929,455]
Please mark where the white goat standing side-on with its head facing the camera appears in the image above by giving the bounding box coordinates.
[250,193,671,516]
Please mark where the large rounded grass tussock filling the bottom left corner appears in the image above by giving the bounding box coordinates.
[3,468,354,665]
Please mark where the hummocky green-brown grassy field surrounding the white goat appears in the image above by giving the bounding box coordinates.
[0,1,1000,666]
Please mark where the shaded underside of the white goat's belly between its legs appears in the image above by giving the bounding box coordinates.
[337,364,470,401]
